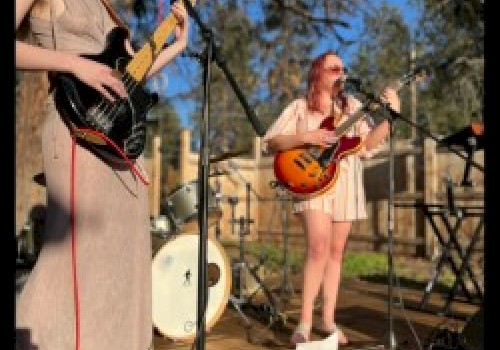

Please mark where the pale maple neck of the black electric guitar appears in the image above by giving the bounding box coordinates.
[126,14,177,81]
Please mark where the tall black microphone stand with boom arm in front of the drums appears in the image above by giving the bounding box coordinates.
[182,0,265,350]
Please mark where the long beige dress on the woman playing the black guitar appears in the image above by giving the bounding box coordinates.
[16,0,152,350]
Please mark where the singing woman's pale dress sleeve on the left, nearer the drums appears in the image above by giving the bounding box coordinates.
[262,99,305,153]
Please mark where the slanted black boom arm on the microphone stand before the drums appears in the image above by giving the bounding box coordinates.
[183,0,266,136]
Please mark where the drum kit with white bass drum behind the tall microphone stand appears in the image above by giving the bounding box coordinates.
[151,175,231,341]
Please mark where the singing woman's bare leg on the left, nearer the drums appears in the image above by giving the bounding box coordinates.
[300,210,332,326]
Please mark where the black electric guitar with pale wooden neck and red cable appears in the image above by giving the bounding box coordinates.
[53,0,194,159]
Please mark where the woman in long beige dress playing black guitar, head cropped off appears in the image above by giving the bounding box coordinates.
[15,0,188,350]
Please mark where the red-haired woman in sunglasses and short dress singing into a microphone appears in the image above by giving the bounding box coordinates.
[263,51,400,345]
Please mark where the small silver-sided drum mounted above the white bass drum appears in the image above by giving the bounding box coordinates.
[162,180,222,232]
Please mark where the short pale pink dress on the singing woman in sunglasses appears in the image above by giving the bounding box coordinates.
[263,97,379,221]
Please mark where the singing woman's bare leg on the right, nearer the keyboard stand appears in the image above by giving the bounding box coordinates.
[323,221,351,344]
